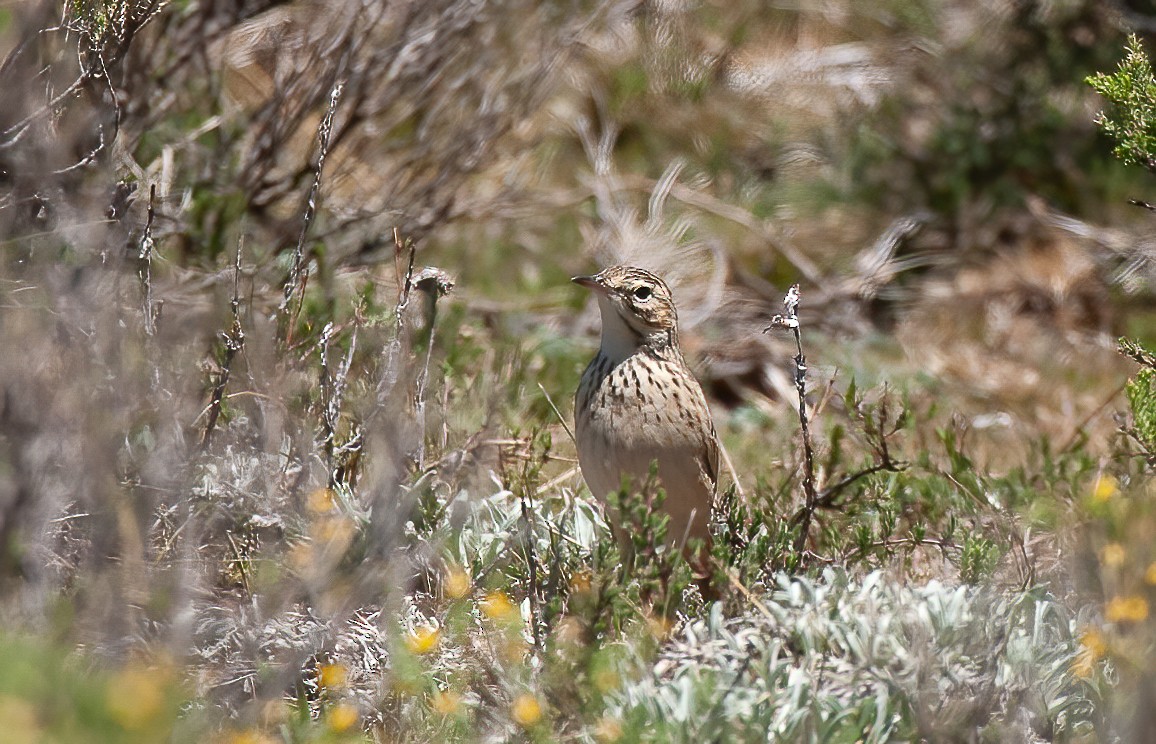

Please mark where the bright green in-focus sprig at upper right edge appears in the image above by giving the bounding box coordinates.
[1087,34,1156,168]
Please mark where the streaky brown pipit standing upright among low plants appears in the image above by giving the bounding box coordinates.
[572,266,719,552]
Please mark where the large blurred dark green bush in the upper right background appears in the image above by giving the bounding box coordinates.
[843,1,1120,220]
